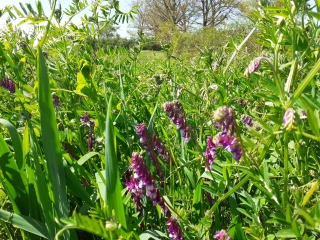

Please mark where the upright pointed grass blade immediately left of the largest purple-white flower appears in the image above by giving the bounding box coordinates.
[105,97,127,228]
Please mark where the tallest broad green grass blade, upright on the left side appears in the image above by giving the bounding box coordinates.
[37,47,75,238]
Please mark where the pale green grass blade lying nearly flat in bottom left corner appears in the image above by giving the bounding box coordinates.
[0,209,49,239]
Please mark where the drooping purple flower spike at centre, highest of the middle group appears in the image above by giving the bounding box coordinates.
[163,101,191,142]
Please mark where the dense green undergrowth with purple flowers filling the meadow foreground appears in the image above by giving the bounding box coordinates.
[0,0,320,240]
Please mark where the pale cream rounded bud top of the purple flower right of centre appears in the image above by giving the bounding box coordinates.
[213,106,235,134]
